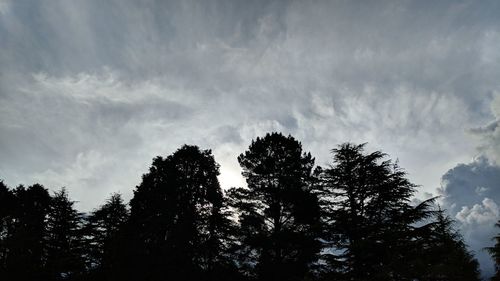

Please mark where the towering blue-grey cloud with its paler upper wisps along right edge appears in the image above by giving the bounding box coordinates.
[439,92,500,274]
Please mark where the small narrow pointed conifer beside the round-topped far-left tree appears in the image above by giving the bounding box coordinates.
[46,188,85,280]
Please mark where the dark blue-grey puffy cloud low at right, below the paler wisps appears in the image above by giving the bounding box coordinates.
[440,157,500,274]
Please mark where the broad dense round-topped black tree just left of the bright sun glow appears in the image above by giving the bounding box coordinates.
[122,145,231,280]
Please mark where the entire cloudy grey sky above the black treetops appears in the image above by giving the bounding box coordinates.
[0,0,500,274]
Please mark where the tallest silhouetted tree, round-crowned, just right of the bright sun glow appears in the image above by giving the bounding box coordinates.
[228,133,320,280]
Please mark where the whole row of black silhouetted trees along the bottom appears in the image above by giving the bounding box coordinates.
[0,133,488,281]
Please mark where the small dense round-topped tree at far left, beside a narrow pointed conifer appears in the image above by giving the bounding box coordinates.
[6,184,50,280]
